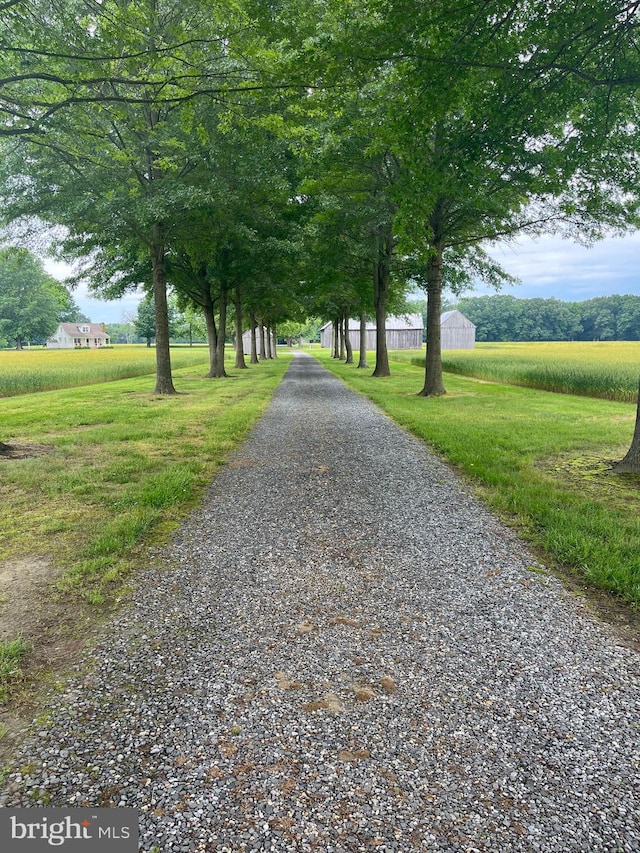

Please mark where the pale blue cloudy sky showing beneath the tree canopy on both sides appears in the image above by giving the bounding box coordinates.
[45,232,640,323]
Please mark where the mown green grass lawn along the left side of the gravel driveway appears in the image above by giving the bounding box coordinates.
[0,353,289,603]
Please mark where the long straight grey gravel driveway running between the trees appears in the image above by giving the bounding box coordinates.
[3,355,640,853]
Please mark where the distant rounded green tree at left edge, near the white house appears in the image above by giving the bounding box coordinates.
[0,247,68,350]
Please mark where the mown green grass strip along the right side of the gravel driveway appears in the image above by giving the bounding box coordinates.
[314,351,640,604]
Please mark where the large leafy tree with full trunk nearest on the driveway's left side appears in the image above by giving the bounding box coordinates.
[0,0,270,394]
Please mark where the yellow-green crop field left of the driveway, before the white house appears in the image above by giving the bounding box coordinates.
[0,344,209,397]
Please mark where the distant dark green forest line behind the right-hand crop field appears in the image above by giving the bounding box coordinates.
[455,295,640,341]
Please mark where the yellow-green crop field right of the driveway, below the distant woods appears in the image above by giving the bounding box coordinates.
[401,341,640,402]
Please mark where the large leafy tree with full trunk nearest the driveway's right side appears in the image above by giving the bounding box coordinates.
[316,0,639,396]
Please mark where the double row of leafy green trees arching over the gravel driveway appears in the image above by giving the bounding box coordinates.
[0,0,640,464]
